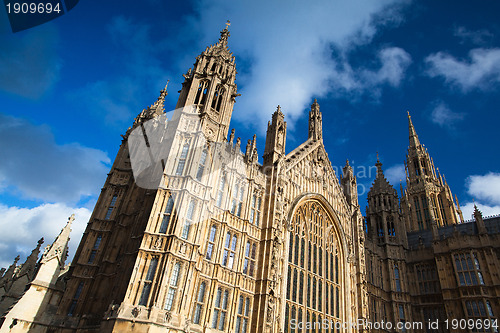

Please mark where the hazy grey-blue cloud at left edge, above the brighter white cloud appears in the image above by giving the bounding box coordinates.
[0,113,110,203]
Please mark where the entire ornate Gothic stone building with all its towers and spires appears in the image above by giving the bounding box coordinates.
[0,27,500,333]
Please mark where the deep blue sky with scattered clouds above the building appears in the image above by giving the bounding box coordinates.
[0,0,500,266]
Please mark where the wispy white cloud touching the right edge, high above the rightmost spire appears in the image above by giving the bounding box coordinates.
[425,48,500,92]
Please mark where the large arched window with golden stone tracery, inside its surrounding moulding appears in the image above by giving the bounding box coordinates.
[285,200,344,332]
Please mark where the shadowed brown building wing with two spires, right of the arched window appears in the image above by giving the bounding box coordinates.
[365,114,500,332]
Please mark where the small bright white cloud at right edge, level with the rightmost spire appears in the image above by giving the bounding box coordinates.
[466,172,500,204]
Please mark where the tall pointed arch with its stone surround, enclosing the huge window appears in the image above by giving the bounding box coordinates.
[281,194,350,331]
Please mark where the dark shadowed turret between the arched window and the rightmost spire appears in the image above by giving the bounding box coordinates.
[365,158,411,330]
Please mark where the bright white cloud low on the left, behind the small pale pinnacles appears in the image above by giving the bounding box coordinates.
[0,203,91,267]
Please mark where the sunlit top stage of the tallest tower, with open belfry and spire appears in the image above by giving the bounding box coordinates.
[176,22,239,142]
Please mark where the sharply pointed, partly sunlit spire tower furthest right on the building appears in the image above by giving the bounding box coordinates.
[401,112,460,231]
